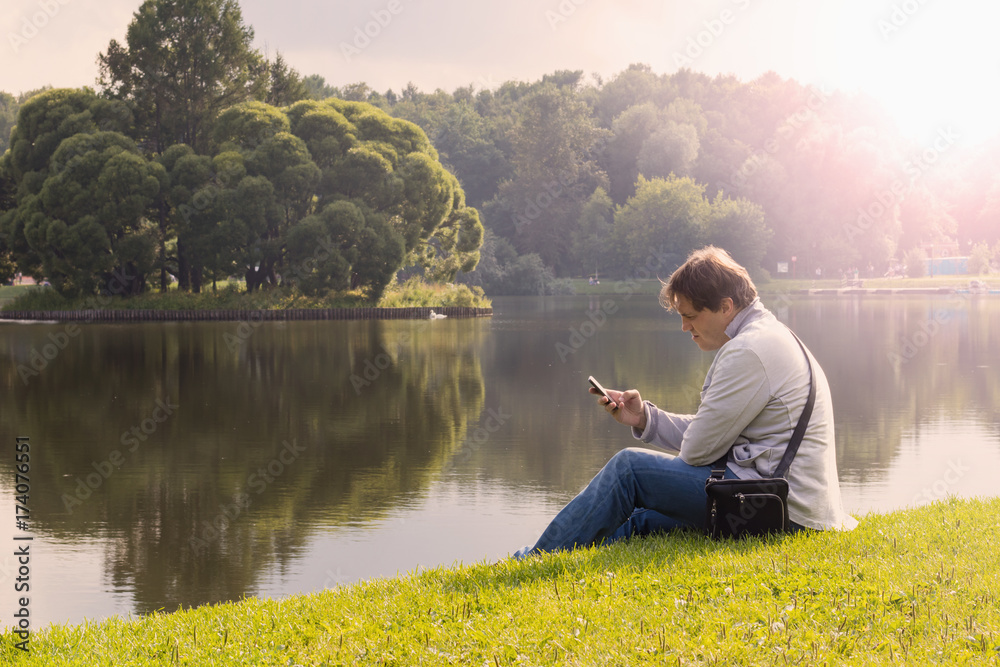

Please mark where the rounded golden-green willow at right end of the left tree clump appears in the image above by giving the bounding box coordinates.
[214,99,483,298]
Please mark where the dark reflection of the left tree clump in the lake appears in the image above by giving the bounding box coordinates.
[0,320,484,611]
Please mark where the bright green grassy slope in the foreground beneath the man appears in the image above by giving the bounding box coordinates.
[0,499,1000,667]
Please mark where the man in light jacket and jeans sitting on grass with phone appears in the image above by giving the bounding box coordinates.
[514,246,857,558]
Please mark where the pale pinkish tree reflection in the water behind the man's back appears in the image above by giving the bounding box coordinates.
[791,295,1000,482]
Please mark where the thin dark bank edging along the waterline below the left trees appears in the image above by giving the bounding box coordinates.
[0,306,493,324]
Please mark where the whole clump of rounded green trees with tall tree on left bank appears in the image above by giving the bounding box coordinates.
[0,0,483,302]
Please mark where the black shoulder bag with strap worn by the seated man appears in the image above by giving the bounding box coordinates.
[705,332,816,539]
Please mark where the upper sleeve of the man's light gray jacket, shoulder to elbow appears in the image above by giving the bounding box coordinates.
[680,347,770,466]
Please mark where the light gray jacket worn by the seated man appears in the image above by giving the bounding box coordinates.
[632,299,857,530]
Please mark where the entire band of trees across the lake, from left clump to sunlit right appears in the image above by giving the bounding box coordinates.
[0,0,1000,294]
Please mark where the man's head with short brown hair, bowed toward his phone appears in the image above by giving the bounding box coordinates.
[660,246,757,351]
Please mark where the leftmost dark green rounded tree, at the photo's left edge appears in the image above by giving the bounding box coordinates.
[0,90,164,296]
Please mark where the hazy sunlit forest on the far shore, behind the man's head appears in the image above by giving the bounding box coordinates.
[360,65,1000,291]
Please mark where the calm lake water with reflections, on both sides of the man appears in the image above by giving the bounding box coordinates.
[0,294,1000,628]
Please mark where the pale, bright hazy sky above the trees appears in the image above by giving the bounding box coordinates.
[0,0,1000,143]
